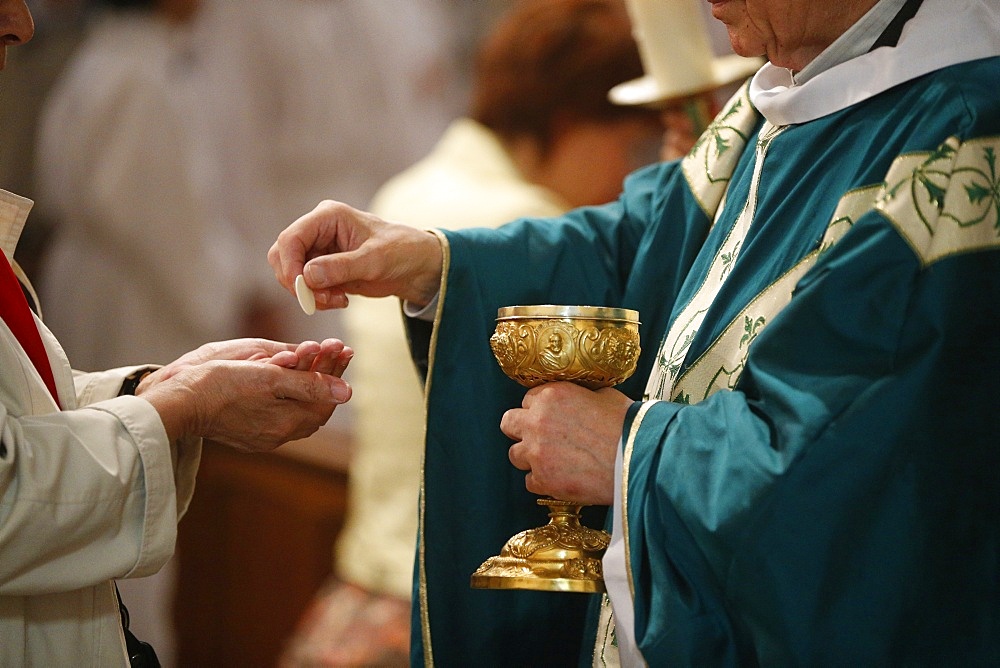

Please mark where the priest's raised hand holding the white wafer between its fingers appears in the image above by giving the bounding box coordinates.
[267,200,444,309]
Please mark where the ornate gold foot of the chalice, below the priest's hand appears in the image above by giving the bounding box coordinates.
[471,499,611,594]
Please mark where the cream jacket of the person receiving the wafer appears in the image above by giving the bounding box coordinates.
[0,191,201,667]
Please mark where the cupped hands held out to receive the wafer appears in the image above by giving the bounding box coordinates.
[136,339,354,451]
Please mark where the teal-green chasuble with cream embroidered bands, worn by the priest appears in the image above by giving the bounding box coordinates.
[413,58,1000,666]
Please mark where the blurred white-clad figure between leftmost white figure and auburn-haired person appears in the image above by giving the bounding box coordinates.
[192,0,460,352]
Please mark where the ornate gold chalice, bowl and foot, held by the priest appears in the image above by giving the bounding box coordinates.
[472,305,639,593]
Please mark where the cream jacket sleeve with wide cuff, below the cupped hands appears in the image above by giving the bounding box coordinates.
[0,396,201,595]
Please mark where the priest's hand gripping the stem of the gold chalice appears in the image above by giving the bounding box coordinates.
[500,382,632,505]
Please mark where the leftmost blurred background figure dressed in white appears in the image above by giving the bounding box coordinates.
[38,0,245,369]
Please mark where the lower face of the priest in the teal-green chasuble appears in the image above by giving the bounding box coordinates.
[708,0,878,70]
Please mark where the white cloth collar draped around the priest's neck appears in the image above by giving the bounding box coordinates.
[750,0,1000,125]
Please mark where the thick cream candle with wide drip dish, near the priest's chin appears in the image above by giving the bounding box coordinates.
[608,0,764,106]
